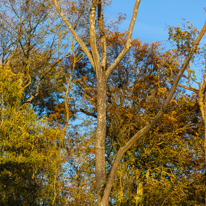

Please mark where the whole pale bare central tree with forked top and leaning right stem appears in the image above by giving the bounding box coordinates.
[53,0,206,206]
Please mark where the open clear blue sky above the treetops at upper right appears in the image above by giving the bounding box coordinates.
[106,0,206,43]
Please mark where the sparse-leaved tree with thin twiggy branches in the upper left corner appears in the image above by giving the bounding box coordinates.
[0,0,70,115]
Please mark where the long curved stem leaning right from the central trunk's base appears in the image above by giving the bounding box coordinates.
[102,21,206,205]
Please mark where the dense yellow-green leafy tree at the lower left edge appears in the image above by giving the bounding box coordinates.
[0,63,69,205]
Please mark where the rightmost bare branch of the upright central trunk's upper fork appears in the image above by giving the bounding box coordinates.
[106,0,141,79]
